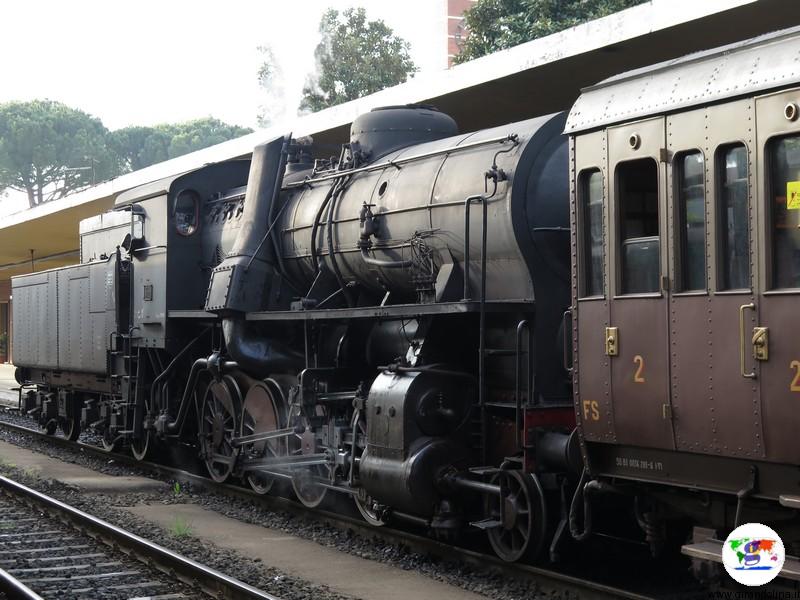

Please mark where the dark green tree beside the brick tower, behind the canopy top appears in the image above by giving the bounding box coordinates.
[454,0,646,63]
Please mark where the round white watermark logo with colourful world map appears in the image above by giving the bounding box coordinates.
[722,523,786,586]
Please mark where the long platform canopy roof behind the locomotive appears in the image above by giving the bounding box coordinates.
[0,0,800,281]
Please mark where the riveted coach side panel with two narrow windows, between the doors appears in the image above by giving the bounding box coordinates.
[667,100,763,457]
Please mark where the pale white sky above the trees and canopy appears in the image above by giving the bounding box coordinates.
[0,0,446,129]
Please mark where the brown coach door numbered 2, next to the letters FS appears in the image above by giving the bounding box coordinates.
[604,117,674,449]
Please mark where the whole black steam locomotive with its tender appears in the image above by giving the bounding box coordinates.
[13,106,580,560]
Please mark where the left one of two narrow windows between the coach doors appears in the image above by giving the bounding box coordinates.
[675,152,706,292]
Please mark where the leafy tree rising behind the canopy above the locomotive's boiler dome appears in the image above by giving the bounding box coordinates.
[300,8,415,111]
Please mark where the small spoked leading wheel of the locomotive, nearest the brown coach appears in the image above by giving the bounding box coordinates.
[485,470,547,562]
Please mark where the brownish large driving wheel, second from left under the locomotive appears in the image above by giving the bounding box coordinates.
[240,379,286,494]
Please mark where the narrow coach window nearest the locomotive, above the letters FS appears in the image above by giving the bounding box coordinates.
[578,169,605,297]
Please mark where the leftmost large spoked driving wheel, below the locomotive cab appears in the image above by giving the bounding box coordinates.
[200,375,242,483]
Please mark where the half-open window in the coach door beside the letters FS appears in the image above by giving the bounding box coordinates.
[617,158,661,294]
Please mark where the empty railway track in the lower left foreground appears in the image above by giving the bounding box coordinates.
[0,468,279,600]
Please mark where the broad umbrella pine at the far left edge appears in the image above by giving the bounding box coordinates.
[0,100,115,207]
